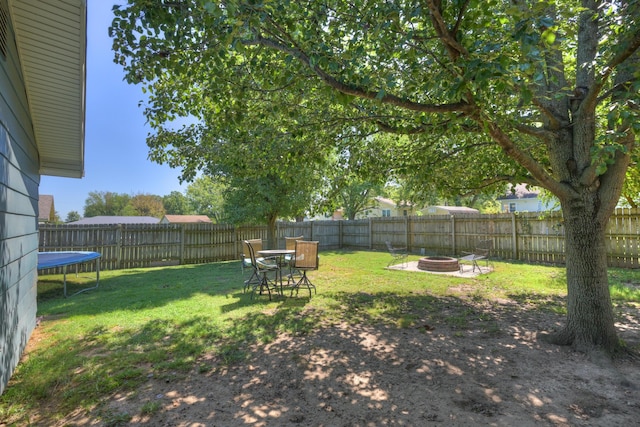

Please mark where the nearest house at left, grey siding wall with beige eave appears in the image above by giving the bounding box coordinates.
[0,0,87,393]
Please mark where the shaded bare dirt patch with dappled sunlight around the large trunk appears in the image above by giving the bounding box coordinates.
[39,301,640,427]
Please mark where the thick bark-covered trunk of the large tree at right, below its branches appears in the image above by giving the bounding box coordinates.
[550,203,619,354]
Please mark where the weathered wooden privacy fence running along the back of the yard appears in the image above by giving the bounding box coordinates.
[39,209,640,270]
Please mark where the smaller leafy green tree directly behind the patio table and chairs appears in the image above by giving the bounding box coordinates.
[147,83,339,245]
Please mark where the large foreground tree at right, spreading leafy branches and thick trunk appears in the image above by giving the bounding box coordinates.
[111,0,640,351]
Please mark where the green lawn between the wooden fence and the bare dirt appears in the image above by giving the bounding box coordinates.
[0,251,640,425]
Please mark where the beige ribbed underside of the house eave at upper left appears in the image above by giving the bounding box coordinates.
[9,0,87,178]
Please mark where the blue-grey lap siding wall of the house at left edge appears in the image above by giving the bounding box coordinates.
[0,12,40,394]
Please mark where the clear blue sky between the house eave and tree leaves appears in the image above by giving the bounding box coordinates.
[40,0,187,220]
